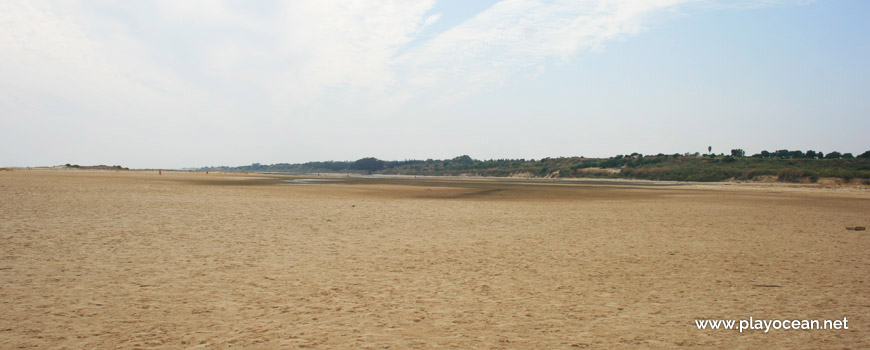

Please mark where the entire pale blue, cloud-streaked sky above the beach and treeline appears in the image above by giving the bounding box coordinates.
[0,0,870,168]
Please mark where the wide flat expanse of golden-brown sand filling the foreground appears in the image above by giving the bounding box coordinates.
[0,170,870,349]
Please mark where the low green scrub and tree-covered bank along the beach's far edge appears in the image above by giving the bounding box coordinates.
[202,149,870,184]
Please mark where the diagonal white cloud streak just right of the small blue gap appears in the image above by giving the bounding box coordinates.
[397,0,691,108]
